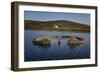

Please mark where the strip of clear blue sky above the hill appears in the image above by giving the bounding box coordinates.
[24,11,90,25]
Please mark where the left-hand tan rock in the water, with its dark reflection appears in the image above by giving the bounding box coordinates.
[32,36,51,47]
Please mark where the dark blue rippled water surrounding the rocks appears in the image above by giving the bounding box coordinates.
[24,30,90,61]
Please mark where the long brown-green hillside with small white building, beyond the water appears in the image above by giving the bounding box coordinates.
[25,20,90,32]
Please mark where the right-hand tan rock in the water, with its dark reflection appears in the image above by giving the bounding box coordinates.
[68,36,84,48]
